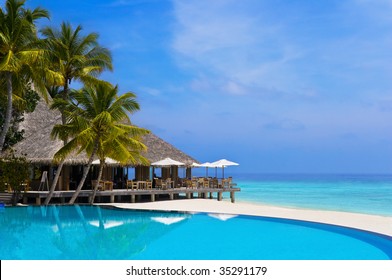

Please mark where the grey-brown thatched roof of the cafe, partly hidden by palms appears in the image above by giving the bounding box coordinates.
[4,97,197,165]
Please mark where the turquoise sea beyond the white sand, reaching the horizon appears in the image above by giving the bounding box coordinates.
[229,174,392,216]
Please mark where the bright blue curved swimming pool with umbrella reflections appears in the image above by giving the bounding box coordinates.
[0,205,392,260]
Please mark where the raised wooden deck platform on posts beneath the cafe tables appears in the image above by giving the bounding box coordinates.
[22,187,241,205]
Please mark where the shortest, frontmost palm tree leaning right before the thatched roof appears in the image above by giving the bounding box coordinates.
[52,83,149,204]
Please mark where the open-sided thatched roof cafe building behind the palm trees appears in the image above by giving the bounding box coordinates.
[7,100,197,190]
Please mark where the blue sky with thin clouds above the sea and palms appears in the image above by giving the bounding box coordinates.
[27,0,392,173]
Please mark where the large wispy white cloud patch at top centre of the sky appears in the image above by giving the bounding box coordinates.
[173,1,314,98]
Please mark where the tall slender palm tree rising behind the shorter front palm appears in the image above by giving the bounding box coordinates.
[41,22,113,205]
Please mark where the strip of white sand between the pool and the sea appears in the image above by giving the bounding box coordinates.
[106,199,392,236]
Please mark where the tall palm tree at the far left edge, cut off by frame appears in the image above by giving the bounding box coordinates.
[0,0,49,150]
